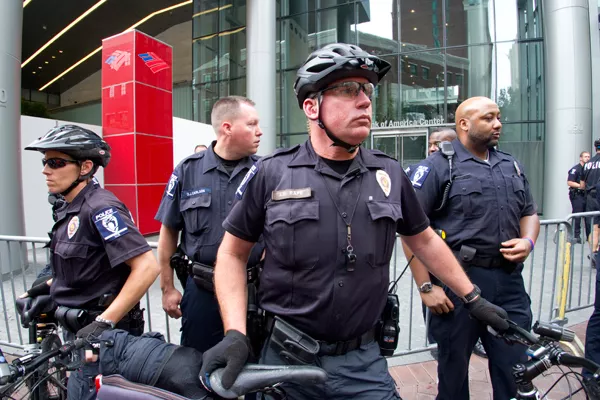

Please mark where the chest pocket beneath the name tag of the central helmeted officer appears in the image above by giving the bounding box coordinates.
[265,200,320,269]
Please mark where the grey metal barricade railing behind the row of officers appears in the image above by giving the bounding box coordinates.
[0,212,600,356]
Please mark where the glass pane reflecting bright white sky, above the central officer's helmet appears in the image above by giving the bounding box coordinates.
[352,0,400,55]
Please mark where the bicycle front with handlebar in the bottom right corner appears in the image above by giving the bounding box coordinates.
[488,320,600,400]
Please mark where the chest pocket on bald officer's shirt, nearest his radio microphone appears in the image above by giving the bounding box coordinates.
[449,178,485,219]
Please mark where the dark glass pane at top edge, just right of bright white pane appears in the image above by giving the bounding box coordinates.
[400,0,442,51]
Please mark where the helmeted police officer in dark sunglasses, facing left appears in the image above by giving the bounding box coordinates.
[25,125,159,399]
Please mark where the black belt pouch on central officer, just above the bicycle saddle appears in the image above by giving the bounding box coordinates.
[269,317,319,365]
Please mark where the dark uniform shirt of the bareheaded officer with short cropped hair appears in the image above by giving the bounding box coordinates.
[155,142,260,266]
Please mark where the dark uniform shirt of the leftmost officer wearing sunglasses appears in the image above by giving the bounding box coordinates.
[50,183,150,308]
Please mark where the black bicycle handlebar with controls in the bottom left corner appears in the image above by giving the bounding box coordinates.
[0,336,88,399]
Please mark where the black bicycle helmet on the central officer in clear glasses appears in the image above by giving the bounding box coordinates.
[294,43,391,108]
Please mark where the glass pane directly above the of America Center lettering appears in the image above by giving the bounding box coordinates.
[399,50,445,122]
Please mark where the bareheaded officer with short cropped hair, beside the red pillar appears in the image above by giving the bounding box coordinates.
[156,96,262,352]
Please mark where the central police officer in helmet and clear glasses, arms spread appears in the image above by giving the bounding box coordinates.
[201,43,507,399]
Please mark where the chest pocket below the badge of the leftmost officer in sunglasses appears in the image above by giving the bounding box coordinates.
[54,241,90,288]
